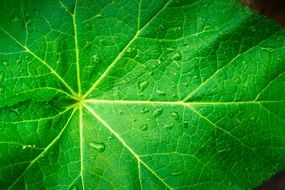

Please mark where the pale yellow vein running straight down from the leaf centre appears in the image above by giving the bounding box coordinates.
[79,105,85,190]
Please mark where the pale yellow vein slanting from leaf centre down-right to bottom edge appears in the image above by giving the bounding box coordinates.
[85,105,172,189]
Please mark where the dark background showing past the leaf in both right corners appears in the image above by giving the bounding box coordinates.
[240,0,285,190]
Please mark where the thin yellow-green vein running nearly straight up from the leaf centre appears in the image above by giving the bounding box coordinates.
[72,0,81,96]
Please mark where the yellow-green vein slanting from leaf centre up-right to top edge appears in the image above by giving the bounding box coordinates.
[83,0,171,98]
